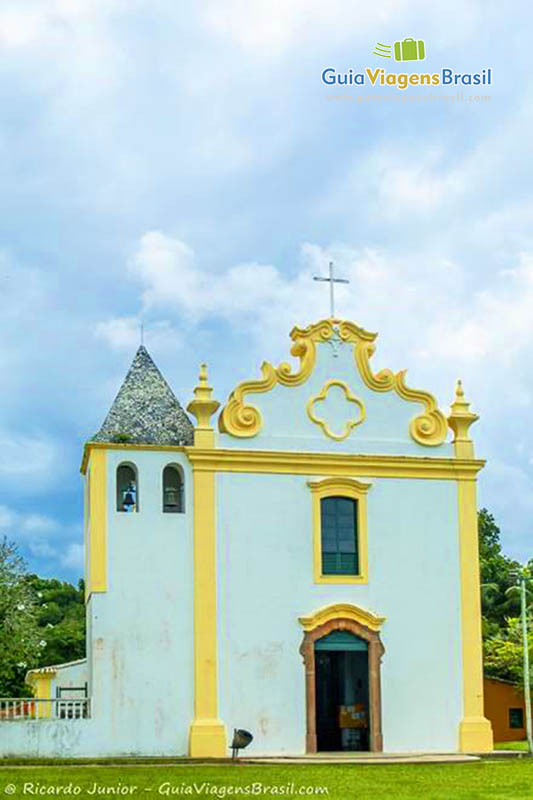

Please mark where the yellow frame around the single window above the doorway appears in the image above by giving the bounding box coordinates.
[307,478,370,584]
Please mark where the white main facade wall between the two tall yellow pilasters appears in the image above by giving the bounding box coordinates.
[217,474,462,754]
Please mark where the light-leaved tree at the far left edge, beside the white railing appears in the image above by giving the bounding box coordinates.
[0,538,42,697]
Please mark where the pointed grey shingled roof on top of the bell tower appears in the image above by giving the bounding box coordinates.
[93,345,194,445]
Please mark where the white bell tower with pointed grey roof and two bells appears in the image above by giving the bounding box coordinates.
[82,345,194,755]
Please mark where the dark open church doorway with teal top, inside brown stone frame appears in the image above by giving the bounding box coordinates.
[315,631,370,752]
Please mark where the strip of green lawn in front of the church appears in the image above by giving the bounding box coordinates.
[0,758,533,800]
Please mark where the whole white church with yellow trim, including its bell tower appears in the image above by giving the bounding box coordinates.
[0,319,492,758]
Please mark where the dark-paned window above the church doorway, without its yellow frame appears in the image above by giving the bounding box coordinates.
[320,497,359,575]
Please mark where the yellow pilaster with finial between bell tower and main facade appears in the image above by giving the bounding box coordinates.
[187,364,227,758]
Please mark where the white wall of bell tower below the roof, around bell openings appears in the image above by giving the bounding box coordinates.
[85,449,193,755]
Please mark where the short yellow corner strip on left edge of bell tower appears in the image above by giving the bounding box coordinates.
[85,449,107,599]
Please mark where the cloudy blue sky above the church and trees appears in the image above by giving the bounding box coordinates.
[0,0,533,582]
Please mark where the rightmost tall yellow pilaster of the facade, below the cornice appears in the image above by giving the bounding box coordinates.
[457,480,493,753]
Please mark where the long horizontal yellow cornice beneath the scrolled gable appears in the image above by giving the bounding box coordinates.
[184,447,485,480]
